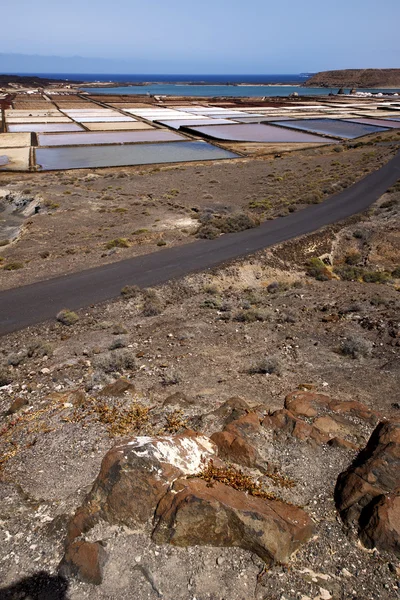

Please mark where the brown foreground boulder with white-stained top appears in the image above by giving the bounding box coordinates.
[60,431,216,583]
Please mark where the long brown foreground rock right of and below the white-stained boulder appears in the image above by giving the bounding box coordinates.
[153,479,313,563]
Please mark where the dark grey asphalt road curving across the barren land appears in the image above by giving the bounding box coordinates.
[0,152,400,335]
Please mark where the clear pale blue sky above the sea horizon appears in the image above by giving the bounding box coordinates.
[0,0,400,74]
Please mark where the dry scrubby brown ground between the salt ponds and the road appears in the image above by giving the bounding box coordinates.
[0,131,400,289]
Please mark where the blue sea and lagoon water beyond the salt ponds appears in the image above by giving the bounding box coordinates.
[13,73,400,98]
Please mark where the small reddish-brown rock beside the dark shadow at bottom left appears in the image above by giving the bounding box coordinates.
[59,541,107,585]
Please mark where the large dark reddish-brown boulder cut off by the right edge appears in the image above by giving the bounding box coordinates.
[335,420,400,555]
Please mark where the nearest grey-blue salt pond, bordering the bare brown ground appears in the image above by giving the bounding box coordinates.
[35,142,238,171]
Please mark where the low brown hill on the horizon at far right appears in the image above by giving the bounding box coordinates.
[303,69,400,89]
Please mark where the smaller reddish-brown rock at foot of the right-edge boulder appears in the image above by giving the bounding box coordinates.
[360,490,400,558]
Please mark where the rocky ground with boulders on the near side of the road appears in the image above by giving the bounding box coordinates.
[0,166,400,600]
